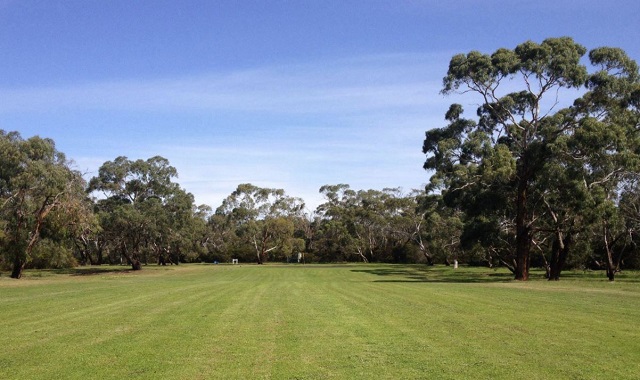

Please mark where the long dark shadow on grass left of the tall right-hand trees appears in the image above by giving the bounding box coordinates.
[351,266,513,283]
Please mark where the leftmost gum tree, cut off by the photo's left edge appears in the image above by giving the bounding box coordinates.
[0,130,84,278]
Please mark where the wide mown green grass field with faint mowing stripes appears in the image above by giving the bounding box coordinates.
[0,265,640,379]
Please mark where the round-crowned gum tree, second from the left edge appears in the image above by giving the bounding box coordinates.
[88,156,196,270]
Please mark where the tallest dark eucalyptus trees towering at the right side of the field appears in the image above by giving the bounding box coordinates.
[423,37,640,280]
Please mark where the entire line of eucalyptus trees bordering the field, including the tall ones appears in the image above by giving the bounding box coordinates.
[0,37,640,280]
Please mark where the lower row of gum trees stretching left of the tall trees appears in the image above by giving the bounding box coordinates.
[0,138,455,278]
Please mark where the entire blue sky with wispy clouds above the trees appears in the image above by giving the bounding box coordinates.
[0,0,640,208]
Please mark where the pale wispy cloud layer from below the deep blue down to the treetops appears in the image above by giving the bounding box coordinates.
[0,54,450,208]
